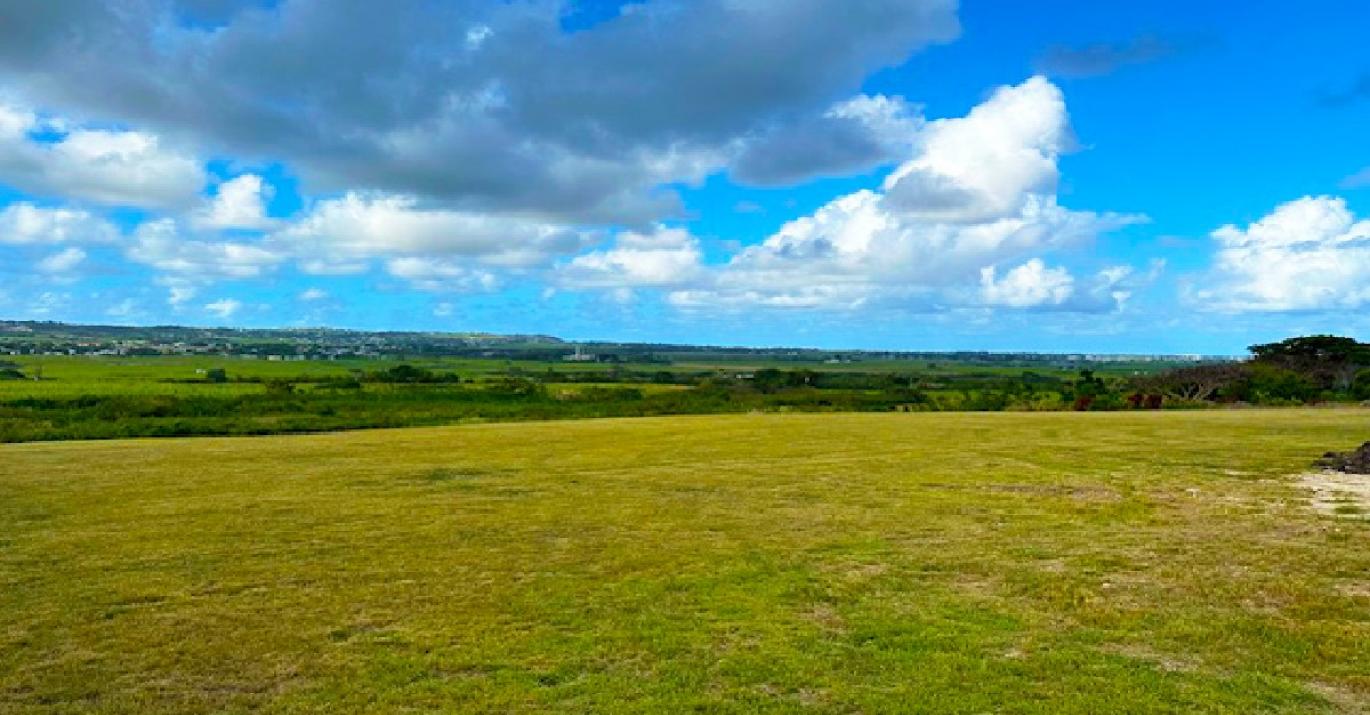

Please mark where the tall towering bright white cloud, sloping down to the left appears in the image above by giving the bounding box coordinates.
[670,77,1140,308]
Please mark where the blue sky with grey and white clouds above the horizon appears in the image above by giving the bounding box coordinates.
[0,0,1370,355]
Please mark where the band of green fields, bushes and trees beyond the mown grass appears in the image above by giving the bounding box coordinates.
[0,336,1370,442]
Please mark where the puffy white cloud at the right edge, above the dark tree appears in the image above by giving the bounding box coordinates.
[1188,196,1370,312]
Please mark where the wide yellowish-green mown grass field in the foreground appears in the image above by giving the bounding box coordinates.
[0,410,1370,714]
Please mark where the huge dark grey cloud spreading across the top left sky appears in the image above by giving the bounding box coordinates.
[0,0,959,223]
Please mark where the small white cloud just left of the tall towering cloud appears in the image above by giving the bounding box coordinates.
[558,226,703,288]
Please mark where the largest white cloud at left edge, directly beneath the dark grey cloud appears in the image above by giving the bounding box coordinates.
[0,105,206,208]
